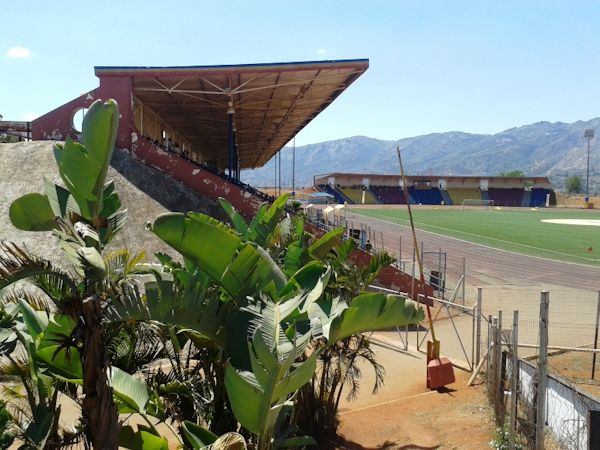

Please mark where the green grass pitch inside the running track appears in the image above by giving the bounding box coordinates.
[352,207,600,266]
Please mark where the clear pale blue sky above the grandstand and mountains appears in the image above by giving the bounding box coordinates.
[0,0,600,145]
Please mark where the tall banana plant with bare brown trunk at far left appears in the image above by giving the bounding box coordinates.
[0,100,127,448]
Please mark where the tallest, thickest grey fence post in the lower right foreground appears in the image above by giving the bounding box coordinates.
[535,291,550,450]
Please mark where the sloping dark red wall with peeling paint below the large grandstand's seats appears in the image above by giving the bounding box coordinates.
[131,139,263,218]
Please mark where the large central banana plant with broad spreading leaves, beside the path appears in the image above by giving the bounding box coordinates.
[141,209,423,449]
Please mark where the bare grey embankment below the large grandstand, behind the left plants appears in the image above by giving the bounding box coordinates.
[0,141,224,259]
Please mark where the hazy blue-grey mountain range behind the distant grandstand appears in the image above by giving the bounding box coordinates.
[242,118,600,192]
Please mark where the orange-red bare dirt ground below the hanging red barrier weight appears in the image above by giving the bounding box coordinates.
[335,370,493,450]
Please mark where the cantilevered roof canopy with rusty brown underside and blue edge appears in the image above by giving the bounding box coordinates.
[95,59,369,169]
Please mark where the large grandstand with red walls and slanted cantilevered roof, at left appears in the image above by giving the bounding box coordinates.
[0,59,369,217]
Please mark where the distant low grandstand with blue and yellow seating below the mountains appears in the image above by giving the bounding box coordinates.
[314,173,556,207]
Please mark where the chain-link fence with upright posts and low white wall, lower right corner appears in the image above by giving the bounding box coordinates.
[482,292,600,450]
